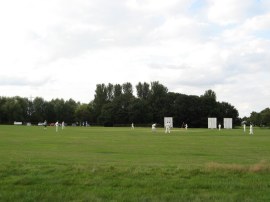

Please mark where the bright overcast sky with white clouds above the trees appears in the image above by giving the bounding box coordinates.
[0,0,270,117]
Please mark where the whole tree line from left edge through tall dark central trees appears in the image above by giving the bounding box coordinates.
[0,81,241,127]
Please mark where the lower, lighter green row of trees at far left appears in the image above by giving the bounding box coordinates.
[0,96,79,124]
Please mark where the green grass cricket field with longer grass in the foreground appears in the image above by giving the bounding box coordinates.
[0,126,270,201]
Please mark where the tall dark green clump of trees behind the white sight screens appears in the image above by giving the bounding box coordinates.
[91,81,239,127]
